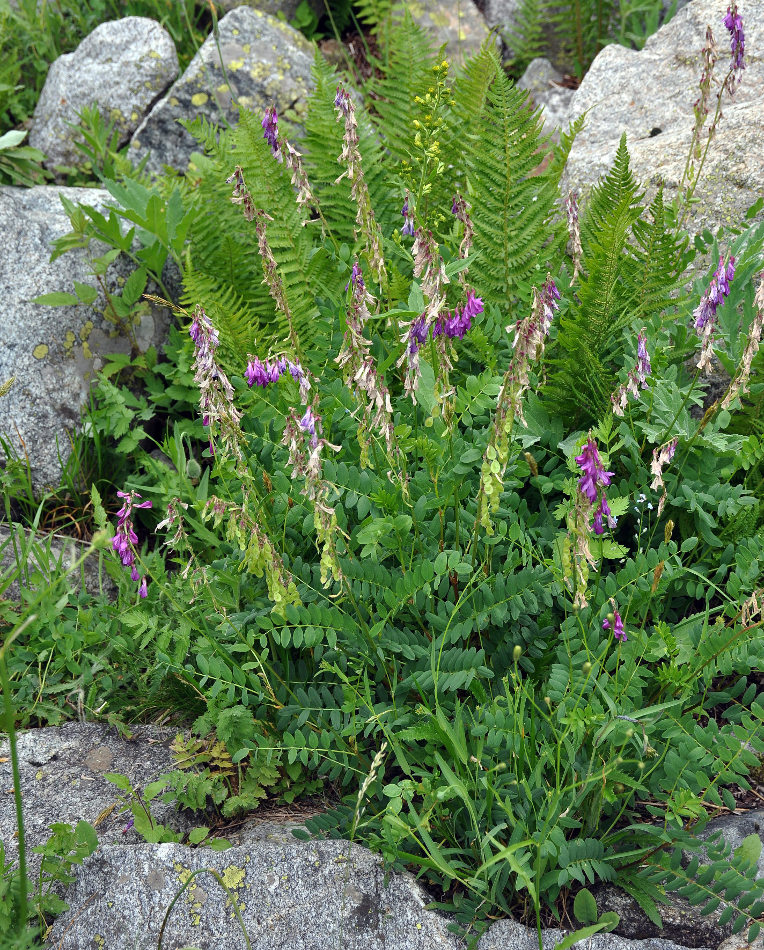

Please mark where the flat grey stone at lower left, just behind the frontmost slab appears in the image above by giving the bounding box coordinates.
[0,728,190,874]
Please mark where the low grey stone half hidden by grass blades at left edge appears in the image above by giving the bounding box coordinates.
[0,525,117,602]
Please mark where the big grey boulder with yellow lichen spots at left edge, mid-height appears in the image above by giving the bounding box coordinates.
[0,185,170,491]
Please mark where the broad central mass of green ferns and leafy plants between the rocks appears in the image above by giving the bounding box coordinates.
[8,13,764,939]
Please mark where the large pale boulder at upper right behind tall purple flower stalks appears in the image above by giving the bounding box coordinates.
[563,0,764,237]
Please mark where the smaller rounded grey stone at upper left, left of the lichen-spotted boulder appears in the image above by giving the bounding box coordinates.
[29,16,178,171]
